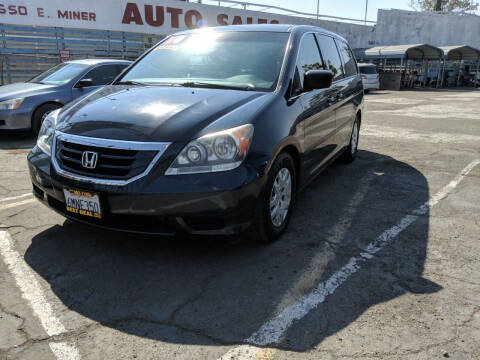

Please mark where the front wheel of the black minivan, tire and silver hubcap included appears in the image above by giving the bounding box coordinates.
[251,152,296,243]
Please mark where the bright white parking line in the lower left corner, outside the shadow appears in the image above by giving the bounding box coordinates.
[0,230,80,360]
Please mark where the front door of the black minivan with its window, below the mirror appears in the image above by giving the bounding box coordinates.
[296,33,343,176]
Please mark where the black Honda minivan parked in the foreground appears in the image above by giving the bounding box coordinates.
[28,25,363,242]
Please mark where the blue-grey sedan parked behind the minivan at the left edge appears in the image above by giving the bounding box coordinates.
[0,59,131,134]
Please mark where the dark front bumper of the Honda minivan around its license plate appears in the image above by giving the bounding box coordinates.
[28,147,266,235]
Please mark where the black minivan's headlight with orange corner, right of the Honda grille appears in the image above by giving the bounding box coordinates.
[165,124,253,175]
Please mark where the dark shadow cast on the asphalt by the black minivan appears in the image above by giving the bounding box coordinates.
[25,151,441,351]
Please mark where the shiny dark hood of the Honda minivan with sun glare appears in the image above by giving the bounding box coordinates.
[57,85,266,142]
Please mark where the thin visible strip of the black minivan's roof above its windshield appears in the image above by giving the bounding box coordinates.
[177,24,346,42]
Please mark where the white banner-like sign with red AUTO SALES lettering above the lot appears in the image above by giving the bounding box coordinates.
[0,0,313,34]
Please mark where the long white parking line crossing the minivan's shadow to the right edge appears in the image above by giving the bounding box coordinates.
[220,159,480,360]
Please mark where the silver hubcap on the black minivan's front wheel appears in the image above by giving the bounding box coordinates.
[270,168,292,227]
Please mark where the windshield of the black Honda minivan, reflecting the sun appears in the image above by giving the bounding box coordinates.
[121,31,289,91]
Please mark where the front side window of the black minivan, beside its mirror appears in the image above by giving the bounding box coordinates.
[294,34,323,89]
